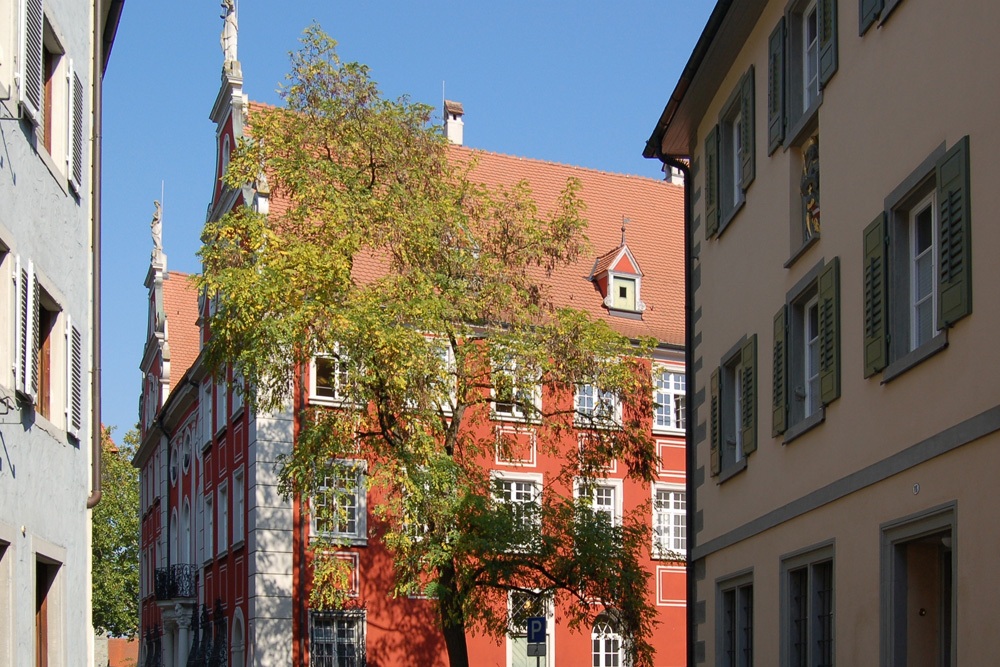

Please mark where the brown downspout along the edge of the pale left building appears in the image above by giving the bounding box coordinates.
[87,0,125,509]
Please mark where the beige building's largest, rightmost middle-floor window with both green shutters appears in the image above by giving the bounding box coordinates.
[863,137,972,382]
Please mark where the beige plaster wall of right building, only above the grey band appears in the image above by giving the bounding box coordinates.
[695,0,1000,543]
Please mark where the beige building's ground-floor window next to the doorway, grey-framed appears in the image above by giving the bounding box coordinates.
[781,544,834,667]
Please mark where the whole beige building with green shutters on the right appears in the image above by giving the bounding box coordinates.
[645,0,1000,667]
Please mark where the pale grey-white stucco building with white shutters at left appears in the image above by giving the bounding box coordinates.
[0,0,124,667]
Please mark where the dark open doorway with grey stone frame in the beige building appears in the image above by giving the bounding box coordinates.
[881,503,958,667]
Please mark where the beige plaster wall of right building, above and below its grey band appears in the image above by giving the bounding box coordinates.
[692,0,1000,665]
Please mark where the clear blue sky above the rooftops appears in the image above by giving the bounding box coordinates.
[102,0,715,437]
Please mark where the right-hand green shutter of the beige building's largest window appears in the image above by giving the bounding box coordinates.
[937,136,972,329]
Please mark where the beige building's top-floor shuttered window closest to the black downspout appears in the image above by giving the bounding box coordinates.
[705,67,756,237]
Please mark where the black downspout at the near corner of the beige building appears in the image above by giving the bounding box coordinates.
[647,144,698,667]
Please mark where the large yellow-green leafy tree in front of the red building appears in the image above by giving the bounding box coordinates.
[200,26,655,667]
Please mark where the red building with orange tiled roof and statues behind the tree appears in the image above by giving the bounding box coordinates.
[135,18,686,667]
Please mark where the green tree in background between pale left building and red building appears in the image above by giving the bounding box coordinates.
[92,427,139,638]
